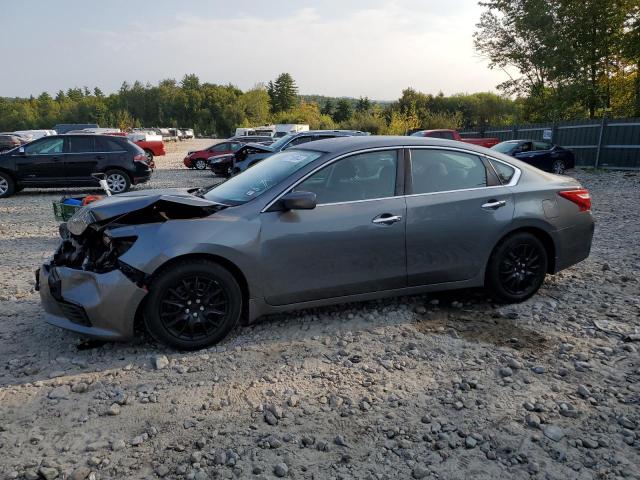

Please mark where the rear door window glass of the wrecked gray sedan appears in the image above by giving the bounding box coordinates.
[411,149,487,193]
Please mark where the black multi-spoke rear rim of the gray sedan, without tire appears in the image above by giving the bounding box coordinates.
[499,243,544,295]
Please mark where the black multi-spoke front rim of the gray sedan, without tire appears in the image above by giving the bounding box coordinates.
[160,275,230,341]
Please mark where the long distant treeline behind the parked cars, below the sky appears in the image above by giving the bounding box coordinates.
[0,73,518,136]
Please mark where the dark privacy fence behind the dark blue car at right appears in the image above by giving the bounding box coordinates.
[460,118,640,170]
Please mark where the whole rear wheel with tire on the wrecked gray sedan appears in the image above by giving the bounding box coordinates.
[485,232,548,303]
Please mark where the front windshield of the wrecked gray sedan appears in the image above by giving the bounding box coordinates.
[204,150,322,205]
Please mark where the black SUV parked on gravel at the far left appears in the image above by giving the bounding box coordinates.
[0,134,151,198]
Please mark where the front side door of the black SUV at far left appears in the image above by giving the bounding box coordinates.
[12,137,66,184]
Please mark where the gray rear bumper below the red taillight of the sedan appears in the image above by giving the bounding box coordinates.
[553,212,595,273]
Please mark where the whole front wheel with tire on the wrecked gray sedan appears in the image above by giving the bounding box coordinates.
[144,260,242,350]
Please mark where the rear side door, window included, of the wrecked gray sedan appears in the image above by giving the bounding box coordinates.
[407,148,514,286]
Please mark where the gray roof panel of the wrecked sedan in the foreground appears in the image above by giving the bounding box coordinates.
[296,135,493,154]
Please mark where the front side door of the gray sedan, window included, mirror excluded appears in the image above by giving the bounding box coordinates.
[260,149,406,305]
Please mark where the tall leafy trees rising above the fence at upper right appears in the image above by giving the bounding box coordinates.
[474,0,640,121]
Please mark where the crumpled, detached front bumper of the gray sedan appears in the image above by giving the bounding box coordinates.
[37,263,147,340]
